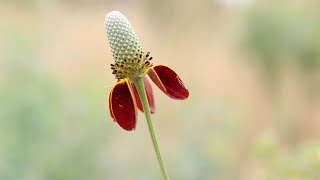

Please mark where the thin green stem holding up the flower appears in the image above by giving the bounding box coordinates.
[133,77,169,180]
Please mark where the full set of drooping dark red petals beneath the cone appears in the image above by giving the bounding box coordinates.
[109,65,189,131]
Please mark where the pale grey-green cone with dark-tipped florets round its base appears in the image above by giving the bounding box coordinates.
[105,11,151,80]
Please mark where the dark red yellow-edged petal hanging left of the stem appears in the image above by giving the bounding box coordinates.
[109,80,137,131]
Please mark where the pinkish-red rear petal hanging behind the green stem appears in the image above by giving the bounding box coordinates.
[131,77,155,113]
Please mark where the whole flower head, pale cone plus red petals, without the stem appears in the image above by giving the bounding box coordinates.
[105,11,189,131]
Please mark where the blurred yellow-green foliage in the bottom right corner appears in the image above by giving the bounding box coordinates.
[254,134,320,180]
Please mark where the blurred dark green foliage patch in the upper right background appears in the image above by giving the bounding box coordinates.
[246,6,320,76]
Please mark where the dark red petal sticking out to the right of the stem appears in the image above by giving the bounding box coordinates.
[148,65,189,100]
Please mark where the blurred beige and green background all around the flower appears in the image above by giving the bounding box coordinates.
[0,0,320,180]
